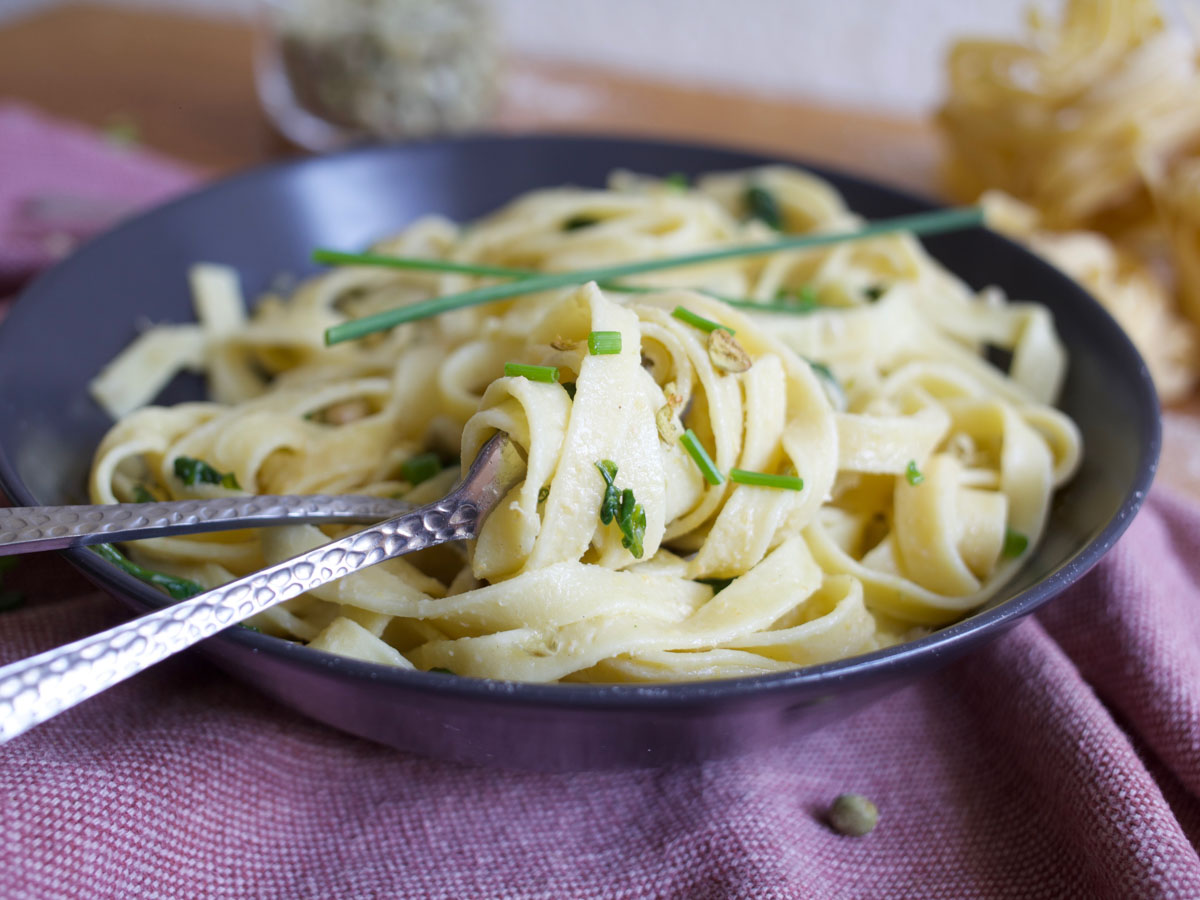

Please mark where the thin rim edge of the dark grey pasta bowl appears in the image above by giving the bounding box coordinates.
[0,131,1162,712]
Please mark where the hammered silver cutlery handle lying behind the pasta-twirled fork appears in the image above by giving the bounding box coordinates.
[0,494,410,557]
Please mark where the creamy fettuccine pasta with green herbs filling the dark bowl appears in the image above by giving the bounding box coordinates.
[90,167,1081,682]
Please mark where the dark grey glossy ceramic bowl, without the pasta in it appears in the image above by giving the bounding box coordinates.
[0,137,1159,769]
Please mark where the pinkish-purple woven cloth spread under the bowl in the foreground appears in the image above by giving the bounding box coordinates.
[0,103,1200,900]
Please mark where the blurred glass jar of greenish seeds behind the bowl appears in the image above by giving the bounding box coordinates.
[256,0,499,151]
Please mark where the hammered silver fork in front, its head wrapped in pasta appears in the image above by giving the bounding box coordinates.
[0,433,524,743]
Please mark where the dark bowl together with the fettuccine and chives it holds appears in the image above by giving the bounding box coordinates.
[0,137,1159,769]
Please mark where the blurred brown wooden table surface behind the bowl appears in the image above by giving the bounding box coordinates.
[0,5,1200,497]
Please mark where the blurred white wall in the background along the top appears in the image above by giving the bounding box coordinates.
[0,0,1198,113]
